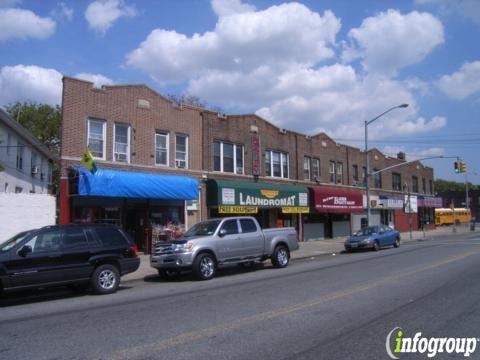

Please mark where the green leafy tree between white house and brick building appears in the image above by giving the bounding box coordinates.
[5,102,62,188]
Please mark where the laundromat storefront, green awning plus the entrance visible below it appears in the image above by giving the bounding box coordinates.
[207,180,310,227]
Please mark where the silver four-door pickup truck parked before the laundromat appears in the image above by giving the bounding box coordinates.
[150,216,298,280]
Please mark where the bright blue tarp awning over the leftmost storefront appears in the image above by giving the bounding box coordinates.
[76,167,198,200]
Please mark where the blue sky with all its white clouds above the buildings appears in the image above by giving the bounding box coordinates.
[0,0,480,183]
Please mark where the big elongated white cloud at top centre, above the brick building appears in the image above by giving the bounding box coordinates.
[127,2,340,83]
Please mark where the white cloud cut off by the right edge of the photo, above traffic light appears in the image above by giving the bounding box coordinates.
[437,61,480,100]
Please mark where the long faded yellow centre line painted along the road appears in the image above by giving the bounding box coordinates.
[111,251,480,359]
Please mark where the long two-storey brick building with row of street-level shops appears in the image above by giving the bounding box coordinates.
[60,77,438,250]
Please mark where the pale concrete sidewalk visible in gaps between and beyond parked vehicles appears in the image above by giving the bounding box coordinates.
[122,224,480,282]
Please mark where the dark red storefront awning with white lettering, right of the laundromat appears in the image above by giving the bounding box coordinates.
[310,187,363,213]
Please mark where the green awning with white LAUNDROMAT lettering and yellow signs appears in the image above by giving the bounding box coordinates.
[207,180,309,213]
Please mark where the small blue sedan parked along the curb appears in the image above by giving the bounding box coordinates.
[345,225,400,251]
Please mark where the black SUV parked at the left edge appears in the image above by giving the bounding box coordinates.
[0,224,140,294]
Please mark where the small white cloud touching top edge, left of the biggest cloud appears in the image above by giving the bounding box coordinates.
[85,0,138,34]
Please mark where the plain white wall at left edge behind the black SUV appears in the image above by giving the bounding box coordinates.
[0,193,55,242]
